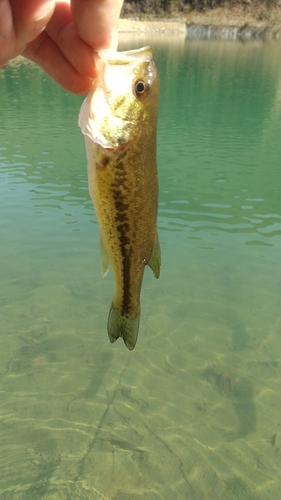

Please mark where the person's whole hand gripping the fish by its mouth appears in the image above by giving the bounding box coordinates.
[0,0,122,94]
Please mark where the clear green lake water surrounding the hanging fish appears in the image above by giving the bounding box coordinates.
[0,36,281,500]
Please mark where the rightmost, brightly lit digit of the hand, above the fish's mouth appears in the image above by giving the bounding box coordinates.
[71,0,123,50]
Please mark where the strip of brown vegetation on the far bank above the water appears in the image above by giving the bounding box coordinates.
[121,0,281,20]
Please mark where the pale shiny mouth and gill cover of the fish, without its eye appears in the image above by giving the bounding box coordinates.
[78,47,152,152]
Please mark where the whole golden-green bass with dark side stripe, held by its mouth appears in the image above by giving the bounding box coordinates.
[78,47,161,351]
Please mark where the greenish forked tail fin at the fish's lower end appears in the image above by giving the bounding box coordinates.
[107,303,140,351]
